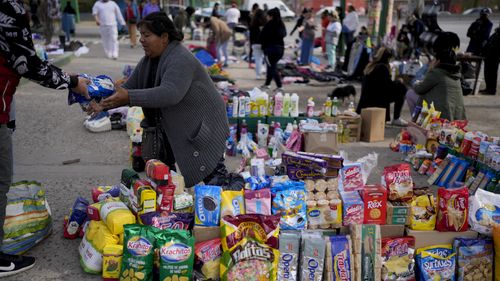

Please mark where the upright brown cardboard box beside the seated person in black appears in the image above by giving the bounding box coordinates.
[361,107,385,142]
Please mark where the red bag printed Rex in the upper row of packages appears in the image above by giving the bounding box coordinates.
[360,185,387,224]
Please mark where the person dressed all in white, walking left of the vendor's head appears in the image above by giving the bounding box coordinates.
[92,0,125,60]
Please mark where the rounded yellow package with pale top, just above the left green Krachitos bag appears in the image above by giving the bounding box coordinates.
[99,199,135,234]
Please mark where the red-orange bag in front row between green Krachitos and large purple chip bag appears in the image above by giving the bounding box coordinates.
[193,238,222,281]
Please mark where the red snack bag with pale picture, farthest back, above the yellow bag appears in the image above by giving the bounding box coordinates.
[382,163,413,201]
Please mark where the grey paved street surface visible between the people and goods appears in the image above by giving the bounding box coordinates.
[4,14,500,280]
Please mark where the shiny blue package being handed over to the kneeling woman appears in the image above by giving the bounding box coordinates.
[68,74,115,108]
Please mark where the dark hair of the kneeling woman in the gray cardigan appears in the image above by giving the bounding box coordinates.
[137,12,184,41]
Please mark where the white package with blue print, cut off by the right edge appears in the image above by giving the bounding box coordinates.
[469,189,500,236]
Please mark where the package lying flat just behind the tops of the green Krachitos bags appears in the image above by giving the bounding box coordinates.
[140,212,194,230]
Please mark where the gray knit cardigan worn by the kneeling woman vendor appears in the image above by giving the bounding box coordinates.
[124,41,229,187]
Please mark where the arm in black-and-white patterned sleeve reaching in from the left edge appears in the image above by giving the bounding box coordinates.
[0,1,86,92]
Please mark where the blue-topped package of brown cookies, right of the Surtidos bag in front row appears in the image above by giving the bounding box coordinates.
[453,238,493,281]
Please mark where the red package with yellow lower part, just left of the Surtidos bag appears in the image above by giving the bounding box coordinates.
[382,237,415,281]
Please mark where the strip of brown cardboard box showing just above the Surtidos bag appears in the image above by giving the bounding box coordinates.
[406,228,477,249]
